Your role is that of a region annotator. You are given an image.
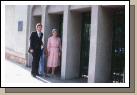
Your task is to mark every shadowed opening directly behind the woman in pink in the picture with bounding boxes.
[45,13,63,77]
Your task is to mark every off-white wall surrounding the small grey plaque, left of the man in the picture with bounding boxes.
[5,5,27,58]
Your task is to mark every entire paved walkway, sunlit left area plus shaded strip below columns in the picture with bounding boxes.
[5,60,87,83]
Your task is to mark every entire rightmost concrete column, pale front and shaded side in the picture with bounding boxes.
[88,6,112,83]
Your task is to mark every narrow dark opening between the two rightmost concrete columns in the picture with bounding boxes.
[80,12,91,77]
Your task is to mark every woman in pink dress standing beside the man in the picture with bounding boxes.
[47,29,61,75]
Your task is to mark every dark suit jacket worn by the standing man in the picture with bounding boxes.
[30,32,43,51]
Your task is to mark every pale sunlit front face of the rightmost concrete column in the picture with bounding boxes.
[88,6,98,82]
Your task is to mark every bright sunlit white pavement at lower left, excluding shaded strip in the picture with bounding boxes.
[5,60,46,83]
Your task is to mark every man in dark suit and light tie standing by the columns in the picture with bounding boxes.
[30,23,43,77]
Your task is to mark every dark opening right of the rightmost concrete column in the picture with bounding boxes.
[111,8,125,82]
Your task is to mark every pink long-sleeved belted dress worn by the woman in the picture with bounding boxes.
[47,36,61,67]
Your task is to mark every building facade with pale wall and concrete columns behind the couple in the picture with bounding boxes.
[5,5,125,83]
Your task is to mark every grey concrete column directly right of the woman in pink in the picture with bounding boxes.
[61,6,81,79]
